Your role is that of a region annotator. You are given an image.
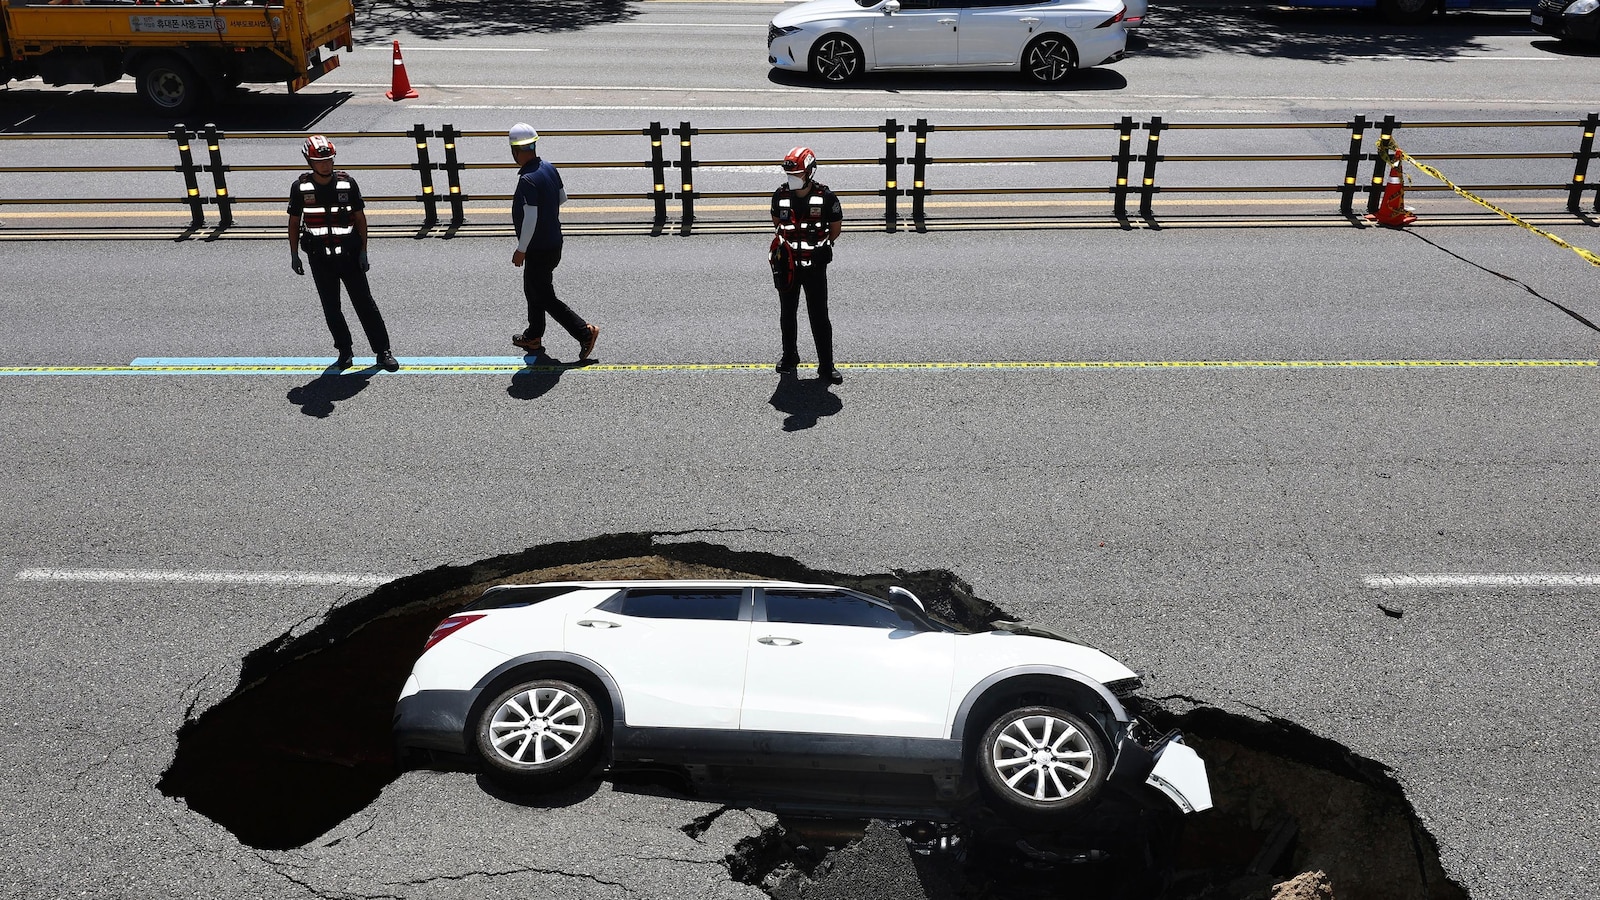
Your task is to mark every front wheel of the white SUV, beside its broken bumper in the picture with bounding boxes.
[973,706,1110,818]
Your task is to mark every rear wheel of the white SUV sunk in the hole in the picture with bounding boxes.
[472,679,605,788]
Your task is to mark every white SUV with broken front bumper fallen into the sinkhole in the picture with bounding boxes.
[394,581,1211,823]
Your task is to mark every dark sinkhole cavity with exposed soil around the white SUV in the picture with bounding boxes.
[160,535,1466,900]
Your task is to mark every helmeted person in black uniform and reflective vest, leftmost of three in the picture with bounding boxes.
[290,135,400,372]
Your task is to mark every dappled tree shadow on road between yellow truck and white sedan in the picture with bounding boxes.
[357,0,638,40]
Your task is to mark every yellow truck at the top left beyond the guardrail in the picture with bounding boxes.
[0,0,355,115]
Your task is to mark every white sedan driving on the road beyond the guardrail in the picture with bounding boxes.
[766,0,1144,83]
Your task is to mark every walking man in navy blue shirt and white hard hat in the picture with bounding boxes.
[510,122,600,359]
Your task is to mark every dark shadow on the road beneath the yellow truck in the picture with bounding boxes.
[0,85,355,135]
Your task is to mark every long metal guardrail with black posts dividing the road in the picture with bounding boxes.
[0,112,1600,237]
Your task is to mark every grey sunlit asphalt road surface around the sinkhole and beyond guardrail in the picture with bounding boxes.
[0,3,1600,898]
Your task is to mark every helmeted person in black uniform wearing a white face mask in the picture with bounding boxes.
[771,147,845,384]
